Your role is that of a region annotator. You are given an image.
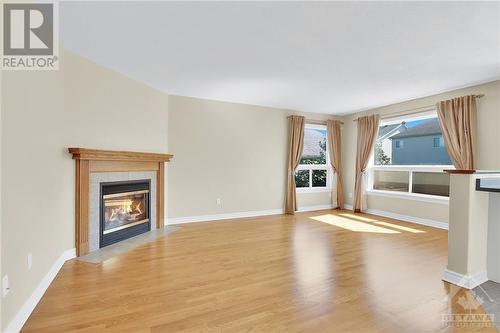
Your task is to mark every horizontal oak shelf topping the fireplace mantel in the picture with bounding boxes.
[68,148,173,162]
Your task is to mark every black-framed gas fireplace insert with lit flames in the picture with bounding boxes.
[99,179,151,247]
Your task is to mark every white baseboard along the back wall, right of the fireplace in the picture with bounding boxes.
[165,205,332,225]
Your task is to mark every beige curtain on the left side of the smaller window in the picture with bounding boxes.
[285,116,305,214]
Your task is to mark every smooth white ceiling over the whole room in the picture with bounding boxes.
[59,2,500,114]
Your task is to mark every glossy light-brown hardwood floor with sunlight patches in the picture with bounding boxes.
[23,211,496,333]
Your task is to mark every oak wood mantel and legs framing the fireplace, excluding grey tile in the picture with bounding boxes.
[68,148,173,256]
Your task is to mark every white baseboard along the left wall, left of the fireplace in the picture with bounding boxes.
[4,249,76,333]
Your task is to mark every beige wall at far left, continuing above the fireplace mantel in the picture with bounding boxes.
[1,51,168,328]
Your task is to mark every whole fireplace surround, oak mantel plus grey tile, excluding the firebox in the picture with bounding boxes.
[68,148,173,256]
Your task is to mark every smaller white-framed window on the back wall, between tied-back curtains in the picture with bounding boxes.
[295,124,331,192]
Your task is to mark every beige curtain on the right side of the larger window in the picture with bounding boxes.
[437,96,477,170]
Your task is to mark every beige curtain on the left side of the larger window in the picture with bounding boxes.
[354,115,380,212]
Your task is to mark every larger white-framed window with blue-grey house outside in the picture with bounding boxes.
[368,111,453,197]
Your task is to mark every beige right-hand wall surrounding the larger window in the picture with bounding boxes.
[342,81,500,222]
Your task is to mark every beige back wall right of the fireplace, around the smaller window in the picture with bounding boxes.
[167,96,336,218]
